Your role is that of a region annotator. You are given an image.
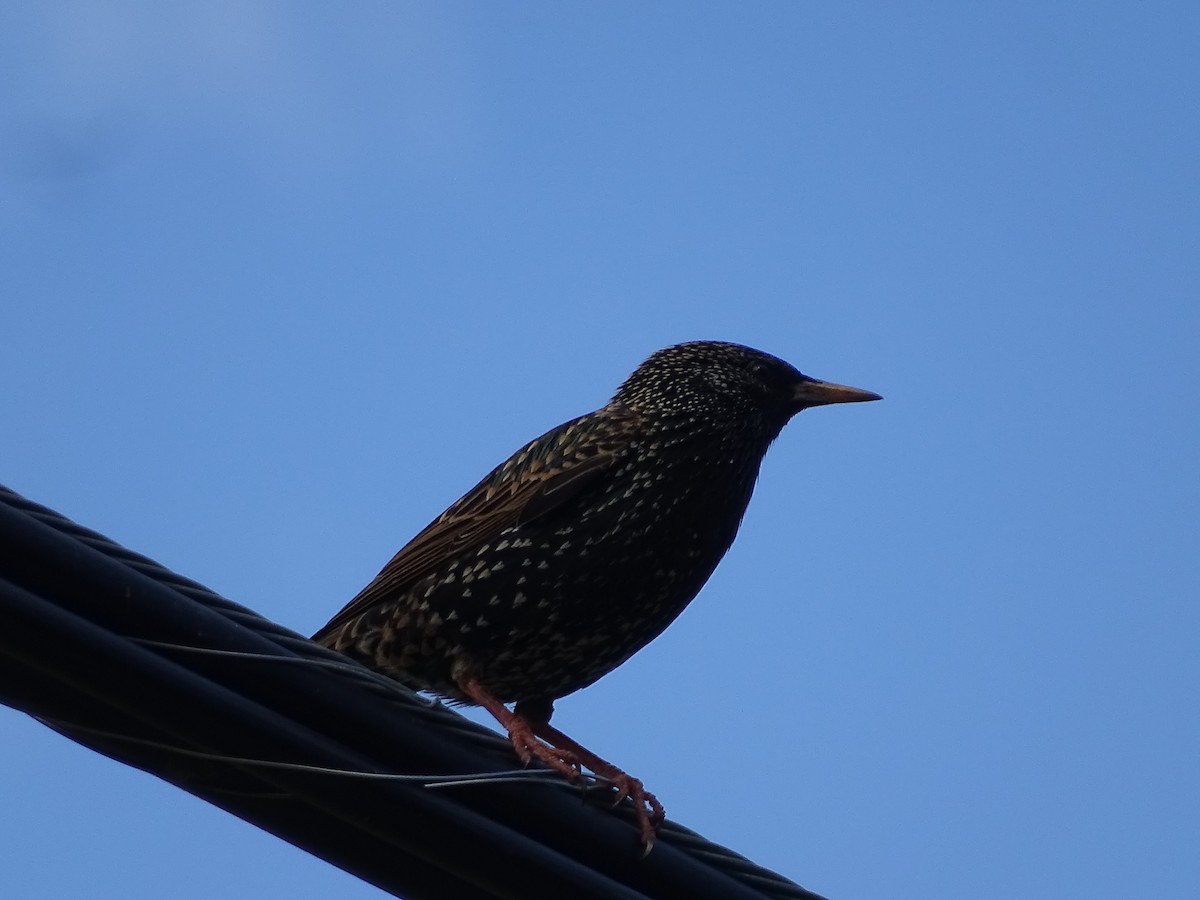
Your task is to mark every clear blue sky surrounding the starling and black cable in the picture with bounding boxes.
[0,0,1200,900]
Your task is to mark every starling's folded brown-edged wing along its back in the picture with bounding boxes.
[313,406,638,642]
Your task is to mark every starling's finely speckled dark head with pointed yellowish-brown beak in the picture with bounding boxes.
[613,341,880,437]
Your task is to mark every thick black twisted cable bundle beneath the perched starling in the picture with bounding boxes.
[0,487,820,900]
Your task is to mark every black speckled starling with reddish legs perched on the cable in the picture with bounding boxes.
[313,341,880,851]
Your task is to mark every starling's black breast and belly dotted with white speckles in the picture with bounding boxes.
[373,429,761,701]
